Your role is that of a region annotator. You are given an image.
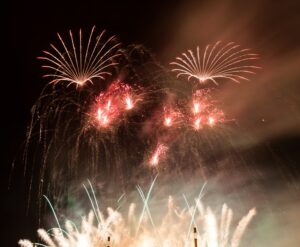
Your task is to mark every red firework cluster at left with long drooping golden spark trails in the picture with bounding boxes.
[23,43,171,216]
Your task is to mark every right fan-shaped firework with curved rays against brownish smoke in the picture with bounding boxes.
[170,41,259,84]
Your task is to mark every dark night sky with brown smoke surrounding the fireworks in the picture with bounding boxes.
[0,0,300,247]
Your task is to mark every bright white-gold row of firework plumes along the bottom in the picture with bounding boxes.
[19,182,256,247]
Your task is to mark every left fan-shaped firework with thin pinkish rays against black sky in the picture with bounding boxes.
[39,26,120,86]
